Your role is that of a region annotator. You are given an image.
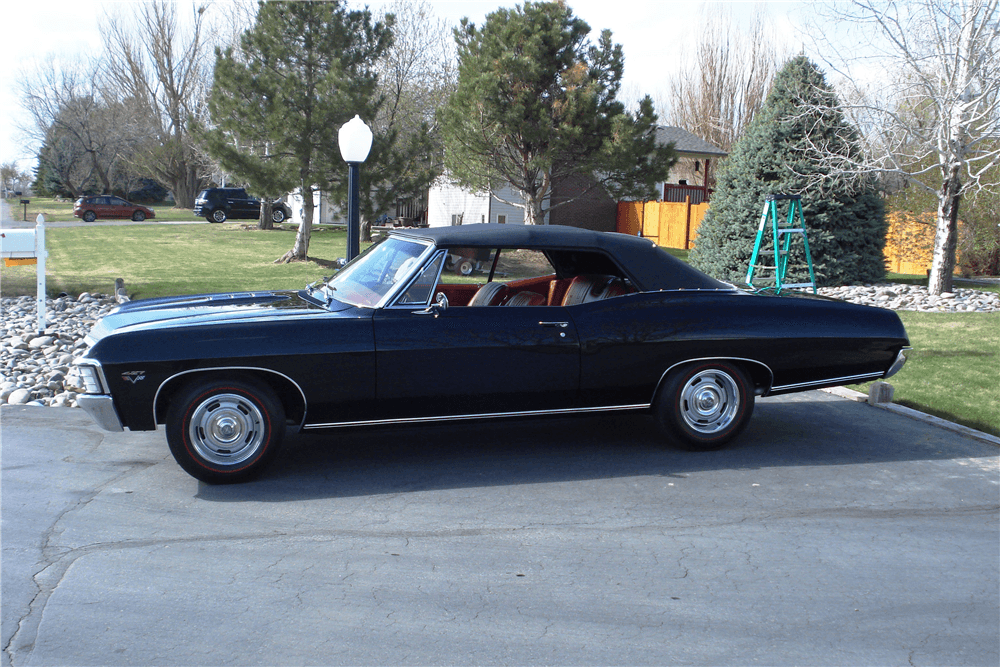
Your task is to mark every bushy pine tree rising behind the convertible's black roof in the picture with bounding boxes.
[439,2,676,224]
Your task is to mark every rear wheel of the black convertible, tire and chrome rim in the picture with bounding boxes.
[653,361,754,451]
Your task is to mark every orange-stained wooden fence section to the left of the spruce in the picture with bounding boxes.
[615,197,708,250]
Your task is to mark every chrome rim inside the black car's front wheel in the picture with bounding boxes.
[188,394,266,466]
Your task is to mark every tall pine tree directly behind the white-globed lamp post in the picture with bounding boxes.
[201,0,439,261]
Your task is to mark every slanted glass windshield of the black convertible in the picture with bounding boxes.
[326,237,429,308]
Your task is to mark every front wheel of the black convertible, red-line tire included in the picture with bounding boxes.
[166,380,285,484]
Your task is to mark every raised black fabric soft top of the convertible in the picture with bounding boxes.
[391,223,730,291]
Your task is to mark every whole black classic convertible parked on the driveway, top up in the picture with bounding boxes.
[74,224,908,483]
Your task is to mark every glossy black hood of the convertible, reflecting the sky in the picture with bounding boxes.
[87,291,350,345]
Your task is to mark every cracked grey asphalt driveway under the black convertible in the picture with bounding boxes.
[0,392,1000,667]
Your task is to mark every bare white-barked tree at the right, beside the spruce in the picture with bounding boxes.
[808,0,1000,294]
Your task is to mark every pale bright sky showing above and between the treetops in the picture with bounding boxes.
[0,0,810,175]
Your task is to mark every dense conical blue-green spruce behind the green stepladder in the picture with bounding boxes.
[691,56,886,286]
